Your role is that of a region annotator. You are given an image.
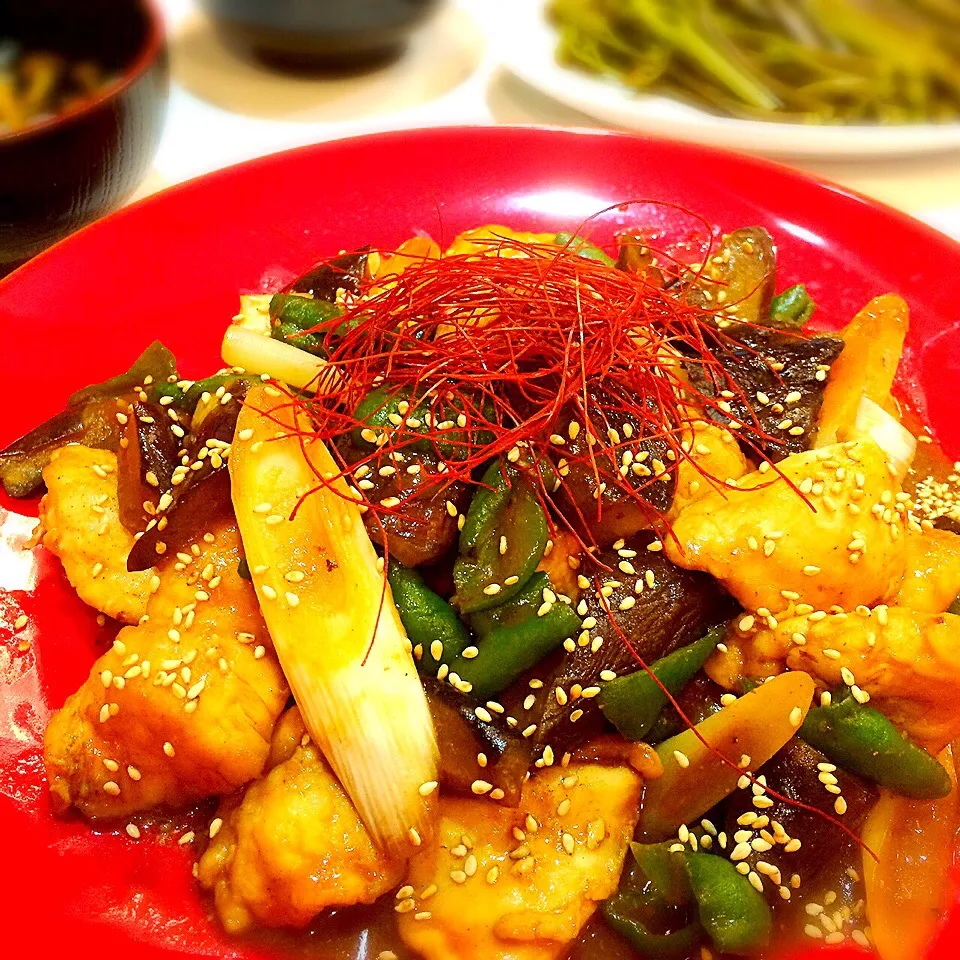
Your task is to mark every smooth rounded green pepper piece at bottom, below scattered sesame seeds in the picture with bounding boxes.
[685,853,773,954]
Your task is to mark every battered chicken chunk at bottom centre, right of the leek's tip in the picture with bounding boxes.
[399,764,641,960]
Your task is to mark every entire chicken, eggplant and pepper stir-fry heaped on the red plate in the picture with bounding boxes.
[0,226,960,960]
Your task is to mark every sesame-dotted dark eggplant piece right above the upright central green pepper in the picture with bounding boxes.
[555,389,676,547]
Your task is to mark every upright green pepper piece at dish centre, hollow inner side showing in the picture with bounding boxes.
[453,460,548,613]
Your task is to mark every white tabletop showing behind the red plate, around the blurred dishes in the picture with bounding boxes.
[148,0,960,239]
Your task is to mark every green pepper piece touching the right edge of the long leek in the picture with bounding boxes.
[387,561,470,676]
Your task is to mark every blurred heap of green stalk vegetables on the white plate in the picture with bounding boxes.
[548,0,960,124]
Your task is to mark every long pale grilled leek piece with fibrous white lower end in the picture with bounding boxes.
[230,385,437,851]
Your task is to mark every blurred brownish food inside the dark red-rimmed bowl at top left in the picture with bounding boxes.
[0,36,115,135]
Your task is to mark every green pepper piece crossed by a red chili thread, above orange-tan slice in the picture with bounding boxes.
[599,625,726,741]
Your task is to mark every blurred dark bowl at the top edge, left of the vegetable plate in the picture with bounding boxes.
[201,0,439,68]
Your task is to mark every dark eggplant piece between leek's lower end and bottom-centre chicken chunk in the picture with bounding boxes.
[424,678,533,807]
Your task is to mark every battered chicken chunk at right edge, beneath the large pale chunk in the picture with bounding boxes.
[724,607,960,753]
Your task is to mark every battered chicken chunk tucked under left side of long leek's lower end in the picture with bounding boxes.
[199,707,405,933]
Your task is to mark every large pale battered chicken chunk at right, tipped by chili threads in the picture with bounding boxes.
[664,440,906,612]
